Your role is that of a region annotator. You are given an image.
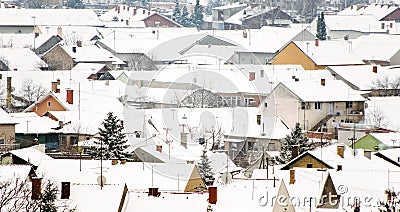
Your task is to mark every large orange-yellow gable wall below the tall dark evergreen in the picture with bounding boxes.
[271,42,326,70]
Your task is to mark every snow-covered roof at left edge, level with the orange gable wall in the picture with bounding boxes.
[0,48,47,71]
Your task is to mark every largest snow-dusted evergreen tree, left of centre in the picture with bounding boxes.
[92,112,131,159]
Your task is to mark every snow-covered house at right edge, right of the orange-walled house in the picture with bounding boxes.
[352,34,400,66]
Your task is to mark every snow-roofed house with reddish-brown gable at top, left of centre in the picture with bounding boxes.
[99,5,181,27]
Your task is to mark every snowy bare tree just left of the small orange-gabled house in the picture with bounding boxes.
[20,78,47,106]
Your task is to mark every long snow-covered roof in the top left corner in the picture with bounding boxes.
[0,8,101,27]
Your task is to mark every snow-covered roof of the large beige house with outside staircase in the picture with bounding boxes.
[281,80,366,102]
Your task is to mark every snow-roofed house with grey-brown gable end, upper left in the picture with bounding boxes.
[42,43,124,70]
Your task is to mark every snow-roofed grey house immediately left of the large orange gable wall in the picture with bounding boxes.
[233,26,315,65]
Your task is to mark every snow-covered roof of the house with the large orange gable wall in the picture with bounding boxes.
[293,40,365,65]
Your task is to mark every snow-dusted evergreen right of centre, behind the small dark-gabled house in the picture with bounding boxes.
[276,123,312,163]
